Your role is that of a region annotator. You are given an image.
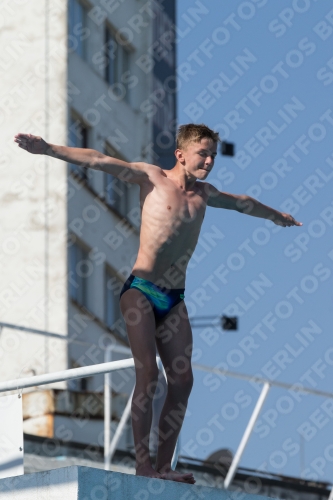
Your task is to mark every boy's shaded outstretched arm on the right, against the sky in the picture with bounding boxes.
[206,182,303,227]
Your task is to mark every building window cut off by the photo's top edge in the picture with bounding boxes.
[68,0,89,59]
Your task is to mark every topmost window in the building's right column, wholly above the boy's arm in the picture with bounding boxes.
[104,26,131,102]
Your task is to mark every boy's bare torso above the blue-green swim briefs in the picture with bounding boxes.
[132,167,208,288]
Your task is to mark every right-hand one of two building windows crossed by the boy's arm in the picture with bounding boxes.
[104,143,130,217]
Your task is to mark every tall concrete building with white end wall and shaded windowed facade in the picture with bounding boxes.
[0,0,175,448]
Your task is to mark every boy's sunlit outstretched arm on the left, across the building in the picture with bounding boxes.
[14,134,150,184]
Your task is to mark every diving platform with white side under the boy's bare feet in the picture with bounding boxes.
[0,465,276,500]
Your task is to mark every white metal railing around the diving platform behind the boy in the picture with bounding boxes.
[0,322,333,492]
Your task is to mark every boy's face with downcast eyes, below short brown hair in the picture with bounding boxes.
[177,138,217,180]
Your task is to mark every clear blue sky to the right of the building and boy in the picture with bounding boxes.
[177,0,333,481]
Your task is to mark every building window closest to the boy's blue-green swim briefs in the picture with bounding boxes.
[105,267,123,330]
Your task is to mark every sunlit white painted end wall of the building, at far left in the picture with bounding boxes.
[0,0,67,379]
